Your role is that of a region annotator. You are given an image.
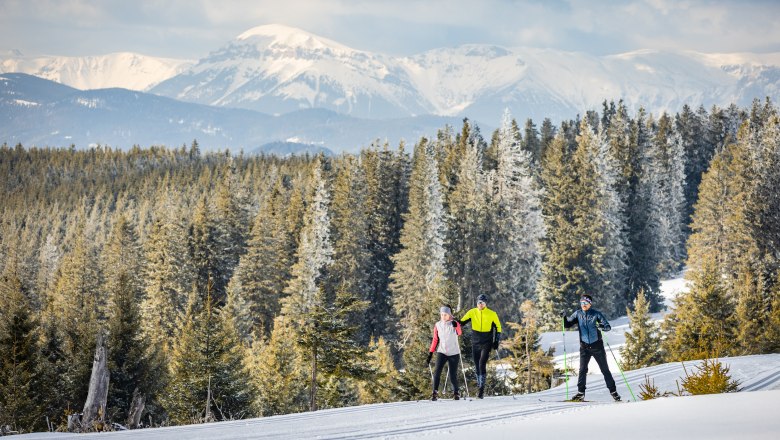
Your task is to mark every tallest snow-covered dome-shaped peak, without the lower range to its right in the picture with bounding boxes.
[153,25,429,118]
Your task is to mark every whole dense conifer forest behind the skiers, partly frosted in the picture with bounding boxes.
[0,100,780,432]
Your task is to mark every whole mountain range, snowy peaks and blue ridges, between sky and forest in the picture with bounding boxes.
[0,25,780,152]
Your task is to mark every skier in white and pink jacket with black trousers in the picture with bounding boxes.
[426,305,462,400]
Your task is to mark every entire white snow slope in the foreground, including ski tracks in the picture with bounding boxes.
[16,354,780,440]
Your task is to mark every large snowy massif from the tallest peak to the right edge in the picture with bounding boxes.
[151,25,780,124]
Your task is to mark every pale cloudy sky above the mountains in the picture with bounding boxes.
[0,0,780,59]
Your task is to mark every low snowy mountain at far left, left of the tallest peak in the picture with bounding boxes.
[0,51,192,90]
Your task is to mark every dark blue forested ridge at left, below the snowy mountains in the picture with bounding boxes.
[0,73,459,151]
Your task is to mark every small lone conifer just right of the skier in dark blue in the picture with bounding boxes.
[620,290,662,370]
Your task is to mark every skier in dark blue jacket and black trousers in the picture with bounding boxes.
[562,295,620,401]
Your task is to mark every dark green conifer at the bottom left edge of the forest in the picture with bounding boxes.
[0,262,46,433]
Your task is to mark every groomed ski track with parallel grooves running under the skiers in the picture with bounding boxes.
[15,354,780,440]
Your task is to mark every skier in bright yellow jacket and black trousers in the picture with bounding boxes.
[460,293,501,399]
